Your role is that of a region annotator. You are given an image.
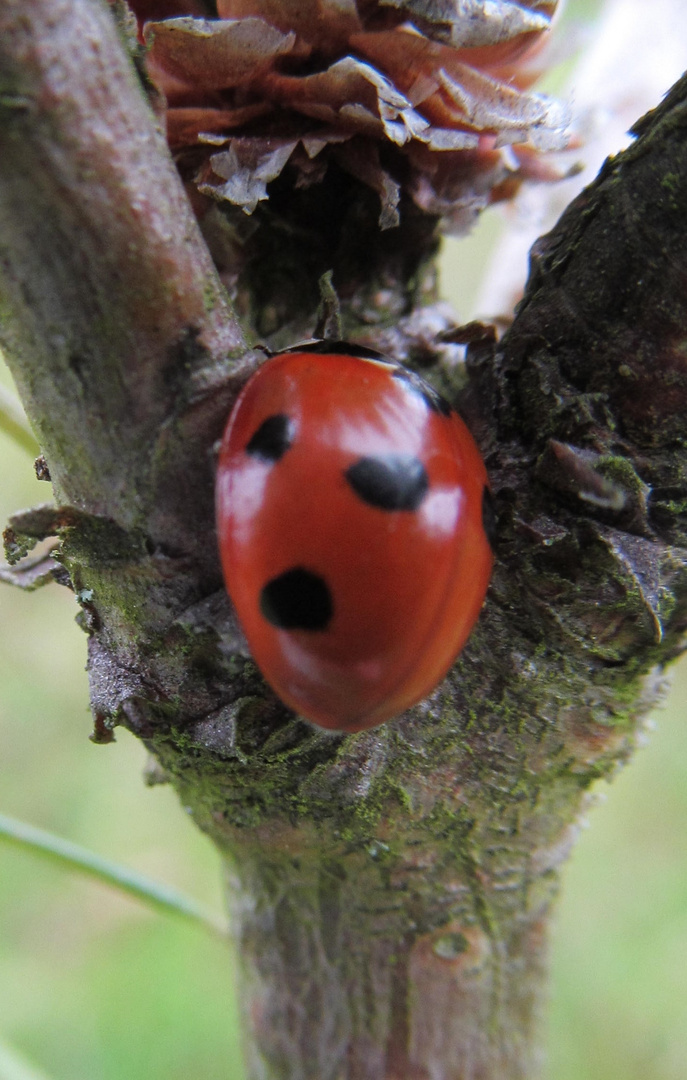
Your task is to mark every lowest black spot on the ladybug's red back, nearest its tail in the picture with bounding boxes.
[260,566,334,630]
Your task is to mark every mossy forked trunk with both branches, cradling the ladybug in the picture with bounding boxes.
[0,6,687,1080]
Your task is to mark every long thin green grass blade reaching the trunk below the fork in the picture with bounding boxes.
[0,814,227,937]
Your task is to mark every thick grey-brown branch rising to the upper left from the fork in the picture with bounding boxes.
[0,0,243,565]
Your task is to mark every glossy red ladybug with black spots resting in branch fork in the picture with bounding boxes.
[216,341,493,731]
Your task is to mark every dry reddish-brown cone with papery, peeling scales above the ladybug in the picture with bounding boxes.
[119,0,567,231]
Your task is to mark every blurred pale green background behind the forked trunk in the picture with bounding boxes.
[0,0,687,1080]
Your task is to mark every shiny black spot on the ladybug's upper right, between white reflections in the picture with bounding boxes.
[345,454,429,510]
